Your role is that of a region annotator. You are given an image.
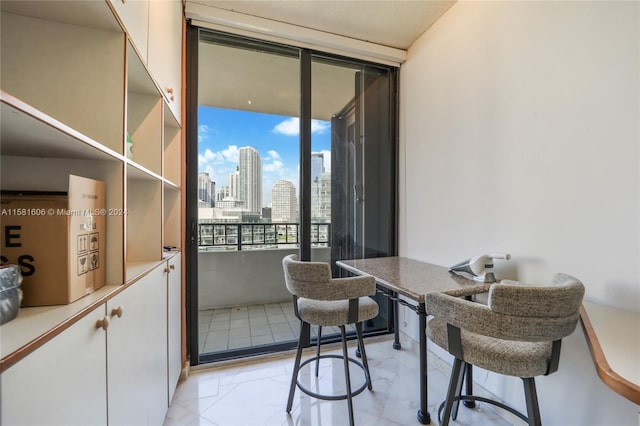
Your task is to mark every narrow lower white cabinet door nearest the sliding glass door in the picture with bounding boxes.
[167,253,182,403]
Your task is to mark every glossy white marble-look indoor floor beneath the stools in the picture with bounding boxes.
[164,334,520,426]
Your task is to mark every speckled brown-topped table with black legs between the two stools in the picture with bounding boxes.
[336,257,490,424]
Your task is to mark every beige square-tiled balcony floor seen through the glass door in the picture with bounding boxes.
[198,301,352,353]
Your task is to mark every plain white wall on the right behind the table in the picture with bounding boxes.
[400,1,640,425]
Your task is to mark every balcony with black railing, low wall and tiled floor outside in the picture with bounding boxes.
[198,223,337,353]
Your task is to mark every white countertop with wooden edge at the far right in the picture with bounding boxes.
[580,302,640,405]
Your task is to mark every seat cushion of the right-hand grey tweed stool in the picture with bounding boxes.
[427,318,551,377]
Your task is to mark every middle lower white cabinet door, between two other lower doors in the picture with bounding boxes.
[107,264,168,425]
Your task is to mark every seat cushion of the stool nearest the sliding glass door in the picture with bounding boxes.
[298,297,378,326]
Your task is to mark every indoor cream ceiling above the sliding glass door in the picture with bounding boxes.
[186,0,455,50]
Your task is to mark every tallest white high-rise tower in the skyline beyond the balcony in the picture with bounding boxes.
[238,146,262,216]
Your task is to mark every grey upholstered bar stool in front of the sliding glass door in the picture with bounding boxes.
[282,255,378,425]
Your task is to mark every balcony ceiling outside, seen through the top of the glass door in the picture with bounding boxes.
[198,42,358,121]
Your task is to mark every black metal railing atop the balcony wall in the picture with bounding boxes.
[198,223,331,250]
